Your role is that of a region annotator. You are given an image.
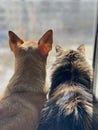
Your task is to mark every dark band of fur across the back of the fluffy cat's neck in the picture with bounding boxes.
[50,61,93,95]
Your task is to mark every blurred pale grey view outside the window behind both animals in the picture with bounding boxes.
[0,0,98,97]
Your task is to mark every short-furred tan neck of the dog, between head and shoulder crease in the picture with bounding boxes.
[4,55,46,96]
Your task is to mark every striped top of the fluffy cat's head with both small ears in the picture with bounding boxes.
[55,45,86,63]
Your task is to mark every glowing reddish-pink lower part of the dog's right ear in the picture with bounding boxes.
[40,43,52,56]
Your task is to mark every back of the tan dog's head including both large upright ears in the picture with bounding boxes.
[9,30,53,71]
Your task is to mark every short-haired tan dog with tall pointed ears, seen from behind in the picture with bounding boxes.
[0,30,53,130]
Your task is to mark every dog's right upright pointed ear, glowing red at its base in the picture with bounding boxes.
[38,30,53,56]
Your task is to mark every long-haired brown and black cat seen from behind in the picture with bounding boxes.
[37,45,95,130]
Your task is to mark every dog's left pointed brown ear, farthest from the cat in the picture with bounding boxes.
[8,31,23,52]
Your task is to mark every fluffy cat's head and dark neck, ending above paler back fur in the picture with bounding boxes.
[52,45,93,92]
